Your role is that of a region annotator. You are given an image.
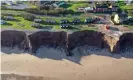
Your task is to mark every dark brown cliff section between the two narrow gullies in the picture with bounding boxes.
[29,31,67,52]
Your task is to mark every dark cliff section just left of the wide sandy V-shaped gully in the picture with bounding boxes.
[68,30,107,50]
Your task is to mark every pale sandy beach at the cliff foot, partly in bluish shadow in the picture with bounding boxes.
[1,48,133,80]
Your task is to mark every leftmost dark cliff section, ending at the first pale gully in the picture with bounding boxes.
[1,30,29,50]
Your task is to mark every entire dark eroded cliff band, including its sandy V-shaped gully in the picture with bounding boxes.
[1,30,133,53]
